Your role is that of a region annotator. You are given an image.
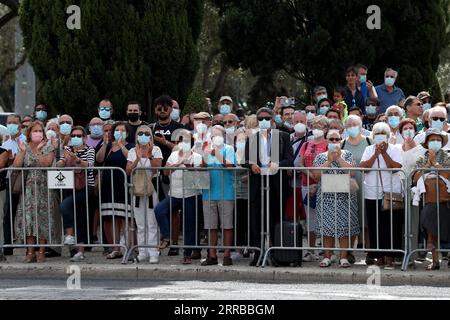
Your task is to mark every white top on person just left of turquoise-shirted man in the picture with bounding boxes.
[167,148,202,199]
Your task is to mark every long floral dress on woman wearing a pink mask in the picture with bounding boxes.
[15,145,55,243]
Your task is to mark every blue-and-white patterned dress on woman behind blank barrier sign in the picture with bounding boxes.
[314,150,360,238]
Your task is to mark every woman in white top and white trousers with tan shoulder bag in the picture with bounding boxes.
[126,125,163,263]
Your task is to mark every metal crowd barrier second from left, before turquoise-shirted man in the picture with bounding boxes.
[124,167,262,261]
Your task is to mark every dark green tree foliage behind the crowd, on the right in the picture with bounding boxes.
[215,0,449,101]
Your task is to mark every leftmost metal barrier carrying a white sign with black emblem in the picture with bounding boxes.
[0,167,130,258]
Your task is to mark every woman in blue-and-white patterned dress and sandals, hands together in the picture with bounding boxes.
[313,130,359,268]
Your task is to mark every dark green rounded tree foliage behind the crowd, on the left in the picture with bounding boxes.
[20,0,203,120]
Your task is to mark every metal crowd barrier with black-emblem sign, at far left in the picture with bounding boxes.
[0,167,130,262]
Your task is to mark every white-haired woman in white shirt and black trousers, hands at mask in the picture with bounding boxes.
[360,122,404,269]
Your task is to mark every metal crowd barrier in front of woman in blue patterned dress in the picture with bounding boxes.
[262,167,409,266]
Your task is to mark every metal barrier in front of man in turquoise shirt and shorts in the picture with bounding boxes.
[124,167,262,261]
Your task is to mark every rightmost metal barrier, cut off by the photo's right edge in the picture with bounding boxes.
[403,168,450,270]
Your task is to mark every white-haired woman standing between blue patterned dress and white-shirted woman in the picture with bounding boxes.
[341,115,373,255]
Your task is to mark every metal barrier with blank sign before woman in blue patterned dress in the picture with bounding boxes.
[262,168,409,266]
